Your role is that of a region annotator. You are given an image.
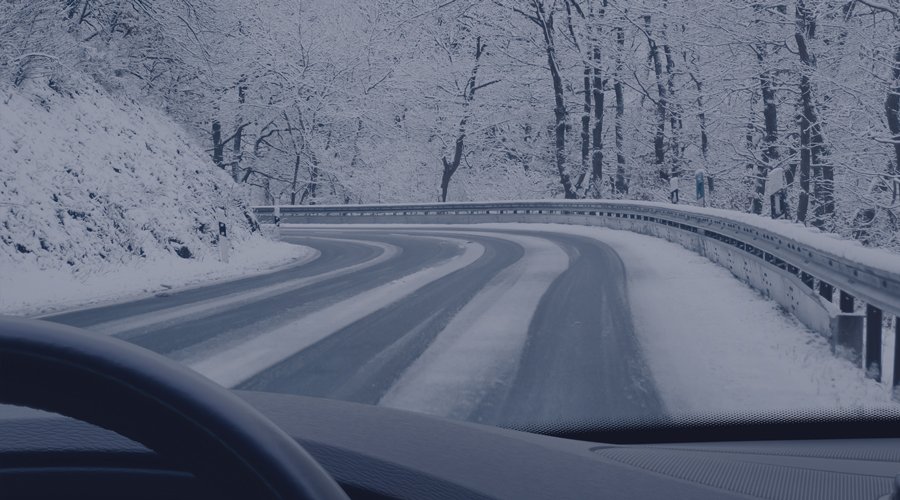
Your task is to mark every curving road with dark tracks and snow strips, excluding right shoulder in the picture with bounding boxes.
[47,226,660,424]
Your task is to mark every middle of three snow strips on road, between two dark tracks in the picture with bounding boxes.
[185,238,484,387]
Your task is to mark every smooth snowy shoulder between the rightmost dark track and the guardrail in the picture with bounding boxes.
[300,224,896,413]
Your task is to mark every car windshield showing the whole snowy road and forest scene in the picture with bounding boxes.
[0,0,900,426]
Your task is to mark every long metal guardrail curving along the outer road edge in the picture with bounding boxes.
[253,201,900,385]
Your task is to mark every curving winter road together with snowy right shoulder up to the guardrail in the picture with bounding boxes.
[47,224,891,424]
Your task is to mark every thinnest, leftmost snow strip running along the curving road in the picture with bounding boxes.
[90,238,402,339]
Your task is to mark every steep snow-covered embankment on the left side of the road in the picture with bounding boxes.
[0,82,310,312]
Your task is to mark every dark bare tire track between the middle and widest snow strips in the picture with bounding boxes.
[236,231,525,405]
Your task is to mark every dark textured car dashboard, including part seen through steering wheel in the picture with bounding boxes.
[0,391,900,500]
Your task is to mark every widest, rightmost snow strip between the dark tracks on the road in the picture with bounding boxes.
[378,231,569,419]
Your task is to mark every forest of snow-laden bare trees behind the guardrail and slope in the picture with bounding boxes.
[0,0,900,248]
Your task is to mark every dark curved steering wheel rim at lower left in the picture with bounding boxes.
[0,317,347,500]
